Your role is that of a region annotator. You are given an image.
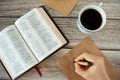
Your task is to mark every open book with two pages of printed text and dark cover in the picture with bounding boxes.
[0,7,67,79]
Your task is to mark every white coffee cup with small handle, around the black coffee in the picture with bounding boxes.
[77,3,106,34]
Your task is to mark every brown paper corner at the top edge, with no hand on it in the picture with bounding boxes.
[41,0,78,16]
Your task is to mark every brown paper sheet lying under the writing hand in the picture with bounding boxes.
[57,38,120,80]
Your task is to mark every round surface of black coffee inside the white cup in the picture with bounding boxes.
[81,9,102,30]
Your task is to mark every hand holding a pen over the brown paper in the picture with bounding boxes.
[74,53,110,80]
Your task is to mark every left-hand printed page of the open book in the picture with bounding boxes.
[0,25,38,79]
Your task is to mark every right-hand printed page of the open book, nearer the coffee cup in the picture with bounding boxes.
[15,9,65,61]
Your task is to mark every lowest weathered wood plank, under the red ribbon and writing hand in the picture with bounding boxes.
[0,49,120,80]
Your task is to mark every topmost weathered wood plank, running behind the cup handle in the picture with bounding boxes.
[0,0,120,19]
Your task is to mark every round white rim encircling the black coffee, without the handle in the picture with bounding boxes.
[78,5,106,32]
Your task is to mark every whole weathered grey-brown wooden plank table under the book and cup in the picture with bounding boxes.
[0,0,120,80]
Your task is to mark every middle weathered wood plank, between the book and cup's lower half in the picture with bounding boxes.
[0,18,120,50]
